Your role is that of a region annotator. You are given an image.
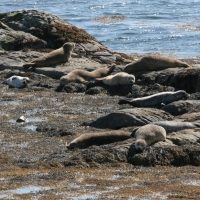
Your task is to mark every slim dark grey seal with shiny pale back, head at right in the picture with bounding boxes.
[119,90,188,107]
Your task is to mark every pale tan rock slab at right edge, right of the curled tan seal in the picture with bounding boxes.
[167,128,200,145]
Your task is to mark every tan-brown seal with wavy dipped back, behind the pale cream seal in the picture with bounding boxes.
[60,66,115,85]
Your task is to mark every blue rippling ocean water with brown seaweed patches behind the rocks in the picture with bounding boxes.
[0,0,200,58]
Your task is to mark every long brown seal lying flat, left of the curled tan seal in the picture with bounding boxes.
[66,130,131,149]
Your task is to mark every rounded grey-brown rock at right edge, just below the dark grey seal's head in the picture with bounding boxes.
[163,100,200,116]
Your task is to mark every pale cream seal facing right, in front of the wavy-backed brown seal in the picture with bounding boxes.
[97,72,135,86]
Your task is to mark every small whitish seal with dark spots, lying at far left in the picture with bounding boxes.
[3,75,30,88]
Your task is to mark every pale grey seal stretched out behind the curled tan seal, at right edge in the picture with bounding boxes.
[151,121,200,133]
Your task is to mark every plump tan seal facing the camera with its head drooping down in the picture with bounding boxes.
[135,124,166,151]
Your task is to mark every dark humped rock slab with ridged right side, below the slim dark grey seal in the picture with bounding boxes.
[89,108,173,129]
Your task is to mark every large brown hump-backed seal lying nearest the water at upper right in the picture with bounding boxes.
[124,55,190,74]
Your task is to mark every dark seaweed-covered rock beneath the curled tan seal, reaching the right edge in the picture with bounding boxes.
[128,144,200,166]
